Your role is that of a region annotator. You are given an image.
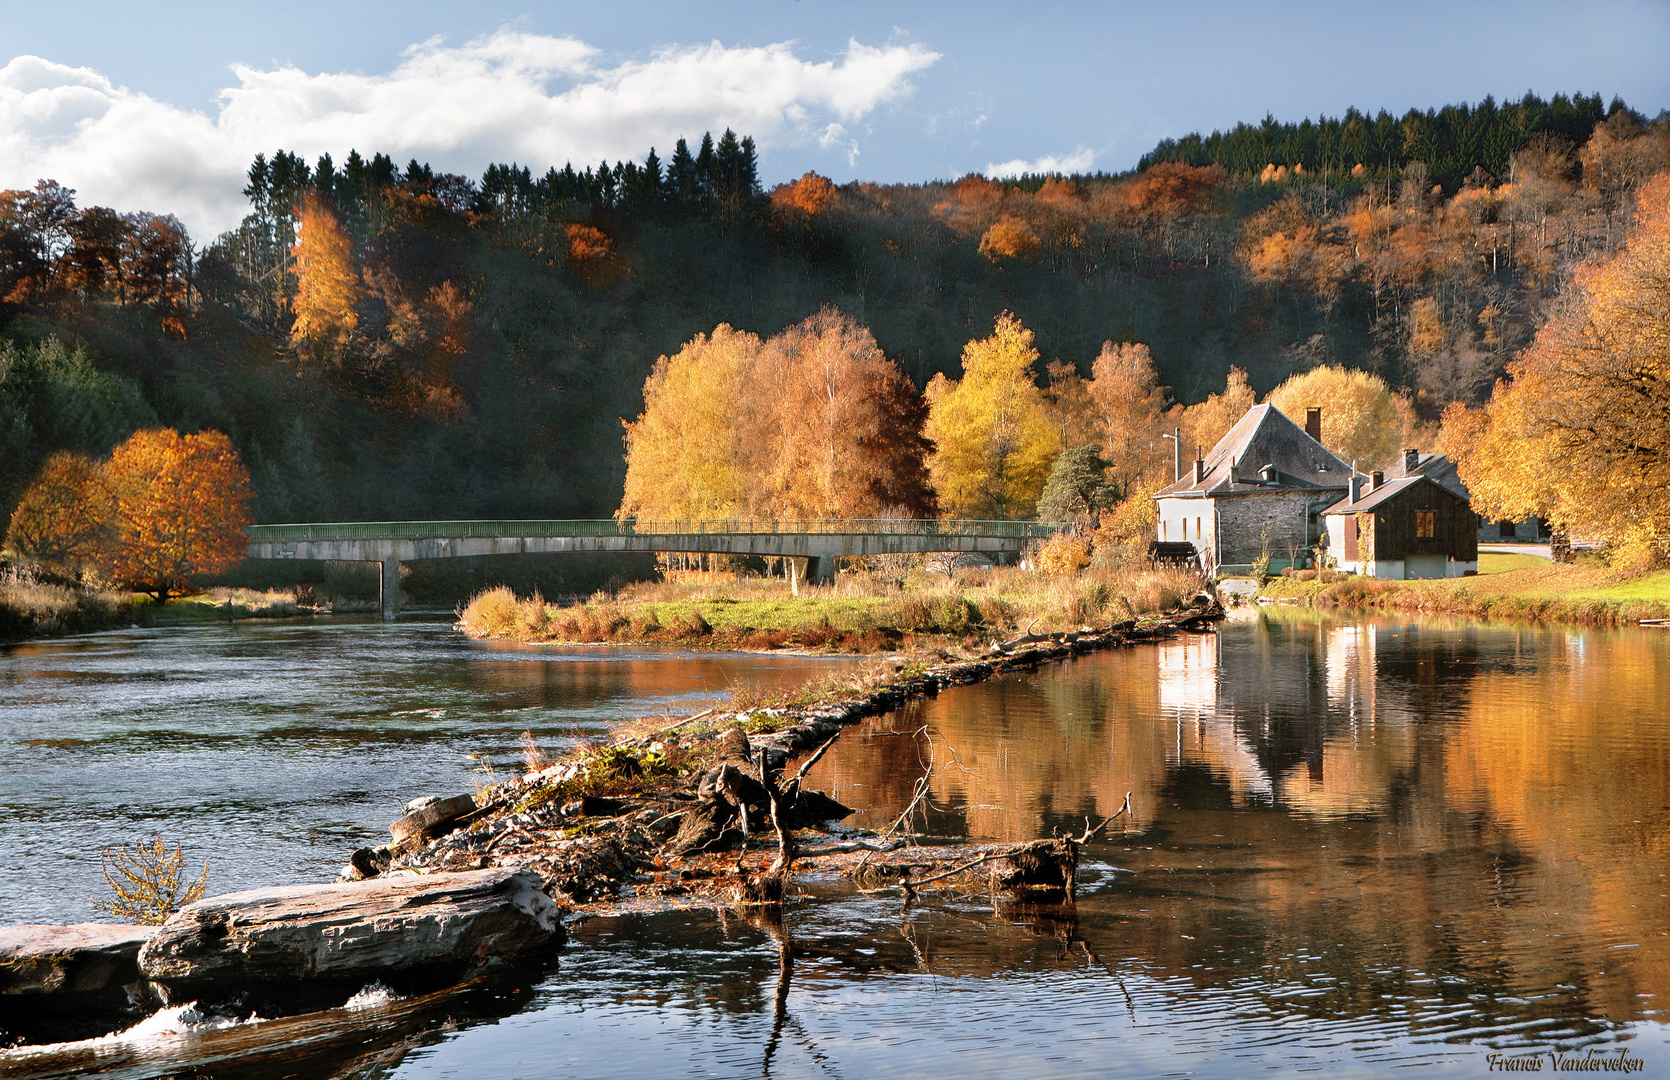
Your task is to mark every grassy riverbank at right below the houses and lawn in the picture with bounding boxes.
[1259,558,1670,626]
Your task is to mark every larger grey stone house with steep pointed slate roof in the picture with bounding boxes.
[1154,404,1351,574]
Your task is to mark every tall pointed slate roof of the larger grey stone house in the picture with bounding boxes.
[1154,404,1351,499]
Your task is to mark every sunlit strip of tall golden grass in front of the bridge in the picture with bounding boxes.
[459,568,1199,653]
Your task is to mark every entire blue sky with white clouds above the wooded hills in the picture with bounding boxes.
[0,0,1670,239]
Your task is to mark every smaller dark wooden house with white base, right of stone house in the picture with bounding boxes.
[1323,451,1478,581]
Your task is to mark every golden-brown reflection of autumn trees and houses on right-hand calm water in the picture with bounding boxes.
[798,618,1670,1032]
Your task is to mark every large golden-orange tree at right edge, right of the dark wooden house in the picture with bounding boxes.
[1445,175,1670,543]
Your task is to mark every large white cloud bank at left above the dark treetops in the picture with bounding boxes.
[0,30,939,239]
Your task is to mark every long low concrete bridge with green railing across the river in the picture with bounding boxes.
[249,517,1069,619]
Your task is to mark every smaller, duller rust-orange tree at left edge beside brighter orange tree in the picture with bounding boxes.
[5,451,114,578]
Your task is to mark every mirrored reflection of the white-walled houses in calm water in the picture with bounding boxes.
[1161,621,1430,816]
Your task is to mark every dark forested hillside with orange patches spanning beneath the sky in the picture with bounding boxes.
[0,97,1670,521]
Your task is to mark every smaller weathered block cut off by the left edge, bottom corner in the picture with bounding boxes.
[0,923,157,1045]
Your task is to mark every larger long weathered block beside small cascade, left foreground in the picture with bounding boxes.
[139,868,563,1015]
